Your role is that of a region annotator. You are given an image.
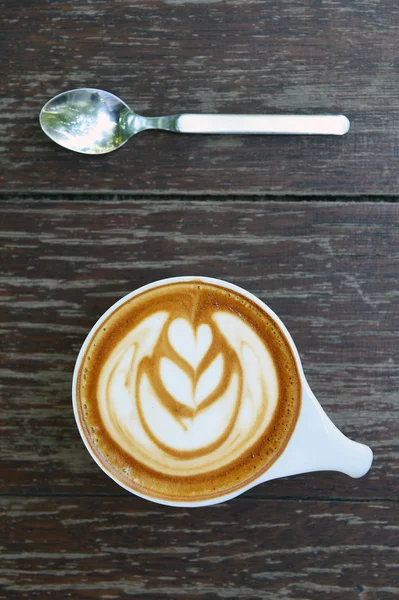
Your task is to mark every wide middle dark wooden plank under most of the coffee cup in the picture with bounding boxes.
[0,197,399,498]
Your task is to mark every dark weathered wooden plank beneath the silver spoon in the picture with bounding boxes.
[0,0,399,195]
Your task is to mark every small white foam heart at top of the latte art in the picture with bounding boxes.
[168,318,213,369]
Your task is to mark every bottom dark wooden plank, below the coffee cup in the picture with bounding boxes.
[0,498,399,600]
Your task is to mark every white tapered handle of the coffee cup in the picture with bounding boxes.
[261,380,373,482]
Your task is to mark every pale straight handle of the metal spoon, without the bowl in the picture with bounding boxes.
[176,114,350,135]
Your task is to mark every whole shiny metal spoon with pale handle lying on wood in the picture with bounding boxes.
[40,88,349,154]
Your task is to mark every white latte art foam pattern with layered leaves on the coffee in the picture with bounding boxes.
[98,311,278,475]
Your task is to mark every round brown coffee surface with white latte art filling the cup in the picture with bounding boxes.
[77,280,301,502]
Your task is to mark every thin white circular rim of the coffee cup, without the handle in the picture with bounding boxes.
[72,275,307,508]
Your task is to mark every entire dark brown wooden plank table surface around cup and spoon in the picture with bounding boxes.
[0,0,399,600]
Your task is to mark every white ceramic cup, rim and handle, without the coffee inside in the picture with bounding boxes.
[72,276,373,507]
